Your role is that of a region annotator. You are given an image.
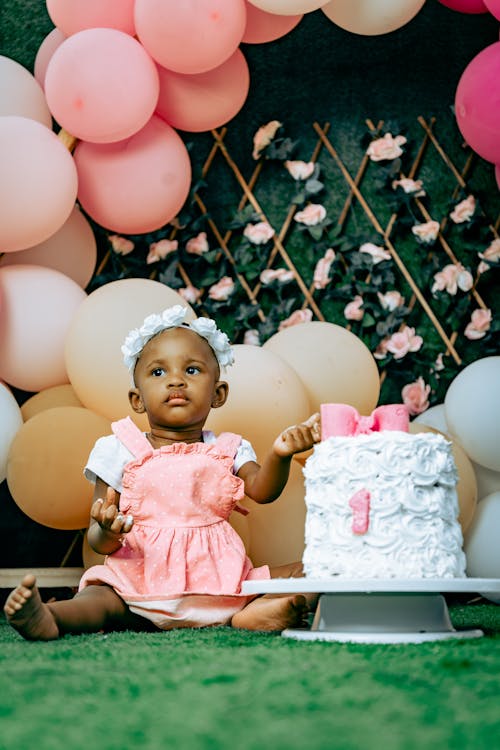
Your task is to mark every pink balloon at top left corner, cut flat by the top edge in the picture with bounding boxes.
[46,0,135,36]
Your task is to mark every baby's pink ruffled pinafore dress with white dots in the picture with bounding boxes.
[80,418,270,629]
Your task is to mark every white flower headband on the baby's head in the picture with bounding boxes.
[122,305,234,375]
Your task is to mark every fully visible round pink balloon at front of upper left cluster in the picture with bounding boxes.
[45,29,160,143]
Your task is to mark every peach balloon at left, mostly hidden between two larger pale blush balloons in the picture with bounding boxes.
[0,205,97,289]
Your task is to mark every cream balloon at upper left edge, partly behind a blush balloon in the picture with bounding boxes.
[0,55,52,129]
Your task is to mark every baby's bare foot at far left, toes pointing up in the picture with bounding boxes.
[4,574,59,641]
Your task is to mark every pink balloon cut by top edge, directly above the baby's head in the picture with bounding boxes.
[135,0,246,73]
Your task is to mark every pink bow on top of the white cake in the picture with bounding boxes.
[320,404,409,440]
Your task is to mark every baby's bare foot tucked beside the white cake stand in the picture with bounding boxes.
[231,594,309,632]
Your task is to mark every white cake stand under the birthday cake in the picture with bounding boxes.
[242,578,500,643]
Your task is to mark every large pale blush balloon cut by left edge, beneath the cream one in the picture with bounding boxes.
[0,116,78,253]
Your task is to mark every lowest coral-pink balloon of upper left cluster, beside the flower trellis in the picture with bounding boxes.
[74,117,191,234]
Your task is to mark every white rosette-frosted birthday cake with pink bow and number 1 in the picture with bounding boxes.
[303,404,465,579]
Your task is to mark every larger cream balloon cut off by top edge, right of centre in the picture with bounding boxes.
[321,0,425,36]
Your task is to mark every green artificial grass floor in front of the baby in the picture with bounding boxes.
[0,604,500,750]
